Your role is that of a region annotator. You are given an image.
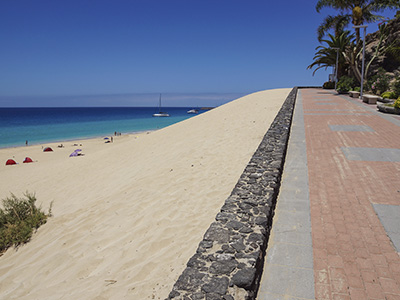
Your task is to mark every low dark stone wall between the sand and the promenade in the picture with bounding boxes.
[168,87,298,300]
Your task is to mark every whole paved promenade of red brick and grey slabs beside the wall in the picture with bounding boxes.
[258,89,400,300]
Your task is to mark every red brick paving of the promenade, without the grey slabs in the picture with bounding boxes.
[301,89,400,300]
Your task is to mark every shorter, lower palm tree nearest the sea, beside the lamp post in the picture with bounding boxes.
[307,30,354,78]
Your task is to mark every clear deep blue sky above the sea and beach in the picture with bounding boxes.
[0,0,394,107]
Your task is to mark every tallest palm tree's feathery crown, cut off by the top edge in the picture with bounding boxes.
[315,0,400,43]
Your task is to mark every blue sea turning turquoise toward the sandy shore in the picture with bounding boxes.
[0,107,204,148]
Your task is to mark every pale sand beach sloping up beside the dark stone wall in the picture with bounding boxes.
[0,89,291,300]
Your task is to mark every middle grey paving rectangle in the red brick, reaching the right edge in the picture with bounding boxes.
[341,147,400,162]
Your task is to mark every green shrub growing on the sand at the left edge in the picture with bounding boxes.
[0,192,51,253]
